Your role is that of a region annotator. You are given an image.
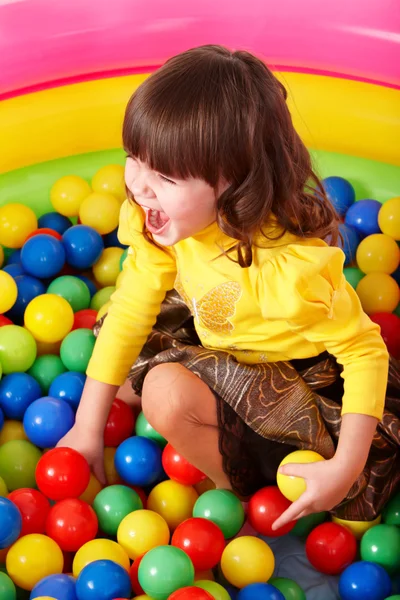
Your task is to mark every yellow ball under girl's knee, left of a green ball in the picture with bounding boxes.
[147,480,199,531]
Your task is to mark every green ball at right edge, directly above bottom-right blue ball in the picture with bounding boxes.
[360,524,400,574]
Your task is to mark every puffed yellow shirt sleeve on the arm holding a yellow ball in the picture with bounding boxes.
[258,245,389,420]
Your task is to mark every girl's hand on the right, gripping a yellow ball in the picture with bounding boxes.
[272,457,358,529]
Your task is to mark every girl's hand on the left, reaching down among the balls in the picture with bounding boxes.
[57,424,106,485]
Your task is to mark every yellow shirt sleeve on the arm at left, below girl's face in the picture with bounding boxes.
[87,200,176,385]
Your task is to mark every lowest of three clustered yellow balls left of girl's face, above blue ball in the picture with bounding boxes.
[79,192,121,235]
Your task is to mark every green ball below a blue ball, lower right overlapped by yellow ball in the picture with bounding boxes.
[93,485,143,535]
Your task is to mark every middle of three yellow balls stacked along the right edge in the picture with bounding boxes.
[357,233,400,275]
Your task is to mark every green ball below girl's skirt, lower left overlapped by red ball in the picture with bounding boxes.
[193,490,244,540]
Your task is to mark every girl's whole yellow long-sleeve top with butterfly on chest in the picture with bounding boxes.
[87,201,388,419]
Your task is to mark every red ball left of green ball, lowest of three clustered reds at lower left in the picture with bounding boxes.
[46,498,98,552]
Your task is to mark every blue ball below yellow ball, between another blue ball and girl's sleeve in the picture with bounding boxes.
[62,225,104,270]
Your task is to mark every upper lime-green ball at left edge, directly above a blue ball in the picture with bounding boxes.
[0,325,37,375]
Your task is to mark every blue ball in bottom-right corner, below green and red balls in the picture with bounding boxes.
[339,561,392,600]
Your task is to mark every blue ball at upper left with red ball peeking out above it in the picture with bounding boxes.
[21,233,65,279]
